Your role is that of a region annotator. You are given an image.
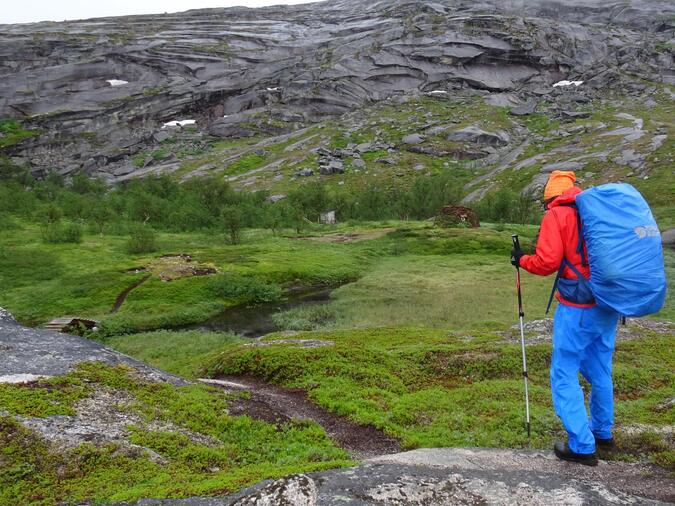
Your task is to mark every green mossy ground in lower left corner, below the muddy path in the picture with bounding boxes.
[0,363,349,505]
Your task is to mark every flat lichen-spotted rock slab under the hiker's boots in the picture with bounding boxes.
[138,448,675,506]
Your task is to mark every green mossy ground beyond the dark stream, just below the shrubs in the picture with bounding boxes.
[0,224,378,333]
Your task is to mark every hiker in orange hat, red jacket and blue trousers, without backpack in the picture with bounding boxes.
[511,170,619,466]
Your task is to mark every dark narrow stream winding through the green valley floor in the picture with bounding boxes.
[189,286,336,338]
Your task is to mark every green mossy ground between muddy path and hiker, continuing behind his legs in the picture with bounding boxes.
[208,328,675,451]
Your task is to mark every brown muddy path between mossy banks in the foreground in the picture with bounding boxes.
[199,376,401,460]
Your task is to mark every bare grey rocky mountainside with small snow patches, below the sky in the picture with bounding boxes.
[0,0,675,193]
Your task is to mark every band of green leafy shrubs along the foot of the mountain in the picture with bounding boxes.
[0,170,539,243]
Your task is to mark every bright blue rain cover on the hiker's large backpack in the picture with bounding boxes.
[576,183,666,316]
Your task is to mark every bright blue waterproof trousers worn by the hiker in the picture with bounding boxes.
[551,304,619,453]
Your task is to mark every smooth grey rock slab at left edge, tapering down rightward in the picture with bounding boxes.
[0,308,187,385]
